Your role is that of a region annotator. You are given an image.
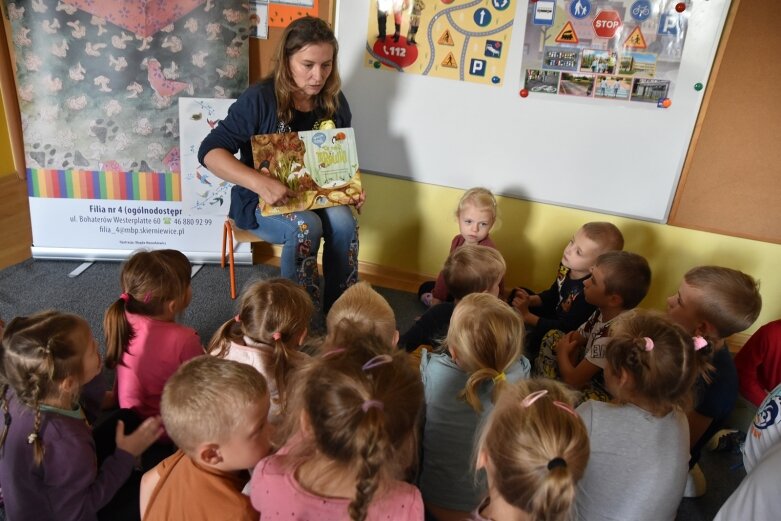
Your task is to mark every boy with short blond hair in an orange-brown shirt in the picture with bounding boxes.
[141,356,271,521]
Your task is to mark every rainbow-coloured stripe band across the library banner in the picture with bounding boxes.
[27,168,182,201]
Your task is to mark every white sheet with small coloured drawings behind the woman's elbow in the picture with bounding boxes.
[179,98,236,215]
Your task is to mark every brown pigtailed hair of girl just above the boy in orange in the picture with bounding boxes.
[207,278,314,409]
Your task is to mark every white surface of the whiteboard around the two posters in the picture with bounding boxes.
[336,0,729,222]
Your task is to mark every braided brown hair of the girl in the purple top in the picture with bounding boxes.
[0,311,89,465]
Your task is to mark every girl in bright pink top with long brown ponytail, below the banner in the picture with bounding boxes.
[103,250,204,418]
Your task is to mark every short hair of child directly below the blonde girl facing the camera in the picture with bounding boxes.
[442,244,507,300]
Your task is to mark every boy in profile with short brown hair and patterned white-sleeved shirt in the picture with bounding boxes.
[535,251,651,401]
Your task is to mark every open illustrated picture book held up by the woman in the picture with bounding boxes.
[252,128,361,216]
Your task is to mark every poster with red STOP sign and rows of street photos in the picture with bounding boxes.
[521,0,692,104]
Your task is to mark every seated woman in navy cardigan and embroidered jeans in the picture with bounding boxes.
[198,16,364,313]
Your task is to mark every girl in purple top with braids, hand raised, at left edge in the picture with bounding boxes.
[0,311,162,520]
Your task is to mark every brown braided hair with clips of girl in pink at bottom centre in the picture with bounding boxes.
[283,335,423,521]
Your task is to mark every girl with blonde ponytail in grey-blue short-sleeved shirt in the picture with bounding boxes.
[420,293,530,521]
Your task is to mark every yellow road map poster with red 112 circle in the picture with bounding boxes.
[365,0,519,85]
